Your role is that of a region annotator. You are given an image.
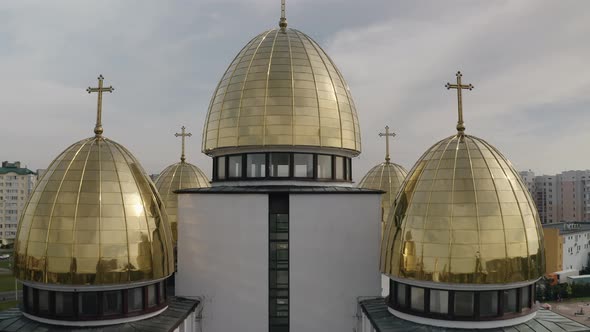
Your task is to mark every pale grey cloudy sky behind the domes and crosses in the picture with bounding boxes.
[0,0,590,181]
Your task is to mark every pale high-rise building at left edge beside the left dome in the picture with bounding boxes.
[0,161,37,245]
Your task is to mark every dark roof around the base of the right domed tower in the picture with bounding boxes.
[360,298,590,332]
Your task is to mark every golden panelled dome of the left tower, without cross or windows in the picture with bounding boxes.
[14,134,174,285]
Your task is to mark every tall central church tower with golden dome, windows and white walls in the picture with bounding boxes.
[176,3,381,332]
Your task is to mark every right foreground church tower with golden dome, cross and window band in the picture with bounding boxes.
[381,72,545,329]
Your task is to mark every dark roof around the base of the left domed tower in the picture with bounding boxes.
[0,297,199,332]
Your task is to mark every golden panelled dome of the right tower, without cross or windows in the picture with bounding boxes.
[381,132,545,284]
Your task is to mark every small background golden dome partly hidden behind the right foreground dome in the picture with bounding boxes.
[358,162,408,222]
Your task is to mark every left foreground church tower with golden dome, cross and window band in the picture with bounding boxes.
[14,76,174,327]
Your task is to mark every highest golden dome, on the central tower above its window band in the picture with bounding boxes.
[202,28,361,155]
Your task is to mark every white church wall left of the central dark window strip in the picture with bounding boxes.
[176,194,268,332]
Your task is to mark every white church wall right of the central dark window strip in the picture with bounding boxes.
[289,194,381,332]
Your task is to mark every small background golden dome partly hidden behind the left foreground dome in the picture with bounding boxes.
[156,162,211,243]
